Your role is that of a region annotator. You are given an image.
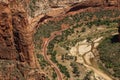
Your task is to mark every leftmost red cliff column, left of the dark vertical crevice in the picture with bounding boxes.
[0,3,18,59]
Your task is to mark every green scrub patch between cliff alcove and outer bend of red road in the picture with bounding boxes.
[34,21,61,48]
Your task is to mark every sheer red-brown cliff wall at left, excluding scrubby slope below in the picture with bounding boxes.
[0,3,35,67]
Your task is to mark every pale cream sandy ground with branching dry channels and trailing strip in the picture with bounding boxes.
[70,37,112,80]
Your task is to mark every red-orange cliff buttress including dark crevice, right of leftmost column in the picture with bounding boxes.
[12,12,35,67]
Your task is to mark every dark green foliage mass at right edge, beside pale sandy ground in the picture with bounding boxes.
[98,37,120,78]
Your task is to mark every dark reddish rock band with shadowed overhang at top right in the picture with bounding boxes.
[68,0,120,12]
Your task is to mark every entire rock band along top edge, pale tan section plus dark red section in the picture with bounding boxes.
[29,0,120,17]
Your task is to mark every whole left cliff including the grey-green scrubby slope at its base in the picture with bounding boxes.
[0,2,38,80]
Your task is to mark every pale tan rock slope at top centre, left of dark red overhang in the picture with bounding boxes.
[29,0,85,17]
